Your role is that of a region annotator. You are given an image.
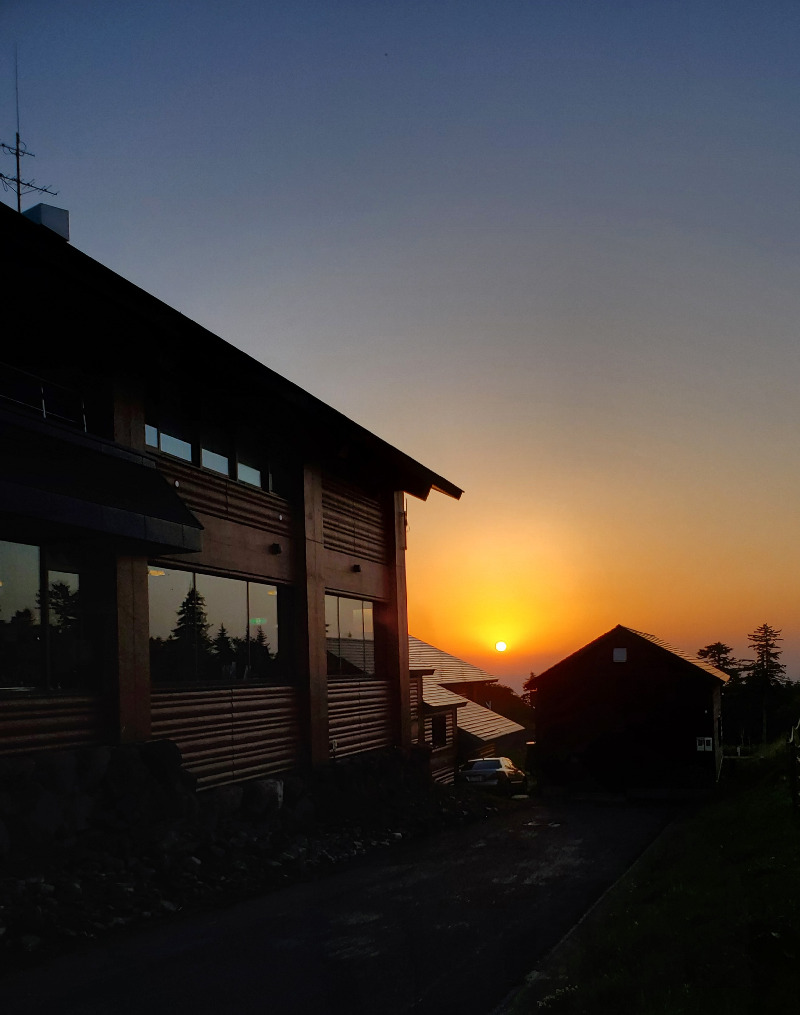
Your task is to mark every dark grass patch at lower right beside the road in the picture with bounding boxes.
[509,751,800,1015]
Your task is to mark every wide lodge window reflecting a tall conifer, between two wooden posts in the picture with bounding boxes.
[148,564,289,685]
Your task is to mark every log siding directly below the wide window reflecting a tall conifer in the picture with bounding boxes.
[152,685,301,788]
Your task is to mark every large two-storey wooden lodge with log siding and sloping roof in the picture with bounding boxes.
[0,206,461,787]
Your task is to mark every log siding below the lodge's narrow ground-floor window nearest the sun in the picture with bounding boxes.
[328,677,393,757]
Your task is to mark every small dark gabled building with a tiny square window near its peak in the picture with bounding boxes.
[526,624,728,791]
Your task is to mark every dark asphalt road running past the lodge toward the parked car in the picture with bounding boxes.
[0,801,672,1015]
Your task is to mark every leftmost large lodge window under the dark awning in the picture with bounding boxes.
[0,540,108,691]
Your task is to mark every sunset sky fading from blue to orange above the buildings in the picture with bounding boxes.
[0,0,800,686]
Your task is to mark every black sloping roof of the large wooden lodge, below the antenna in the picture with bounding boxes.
[0,204,462,500]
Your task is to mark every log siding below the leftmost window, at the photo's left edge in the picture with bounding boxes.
[0,696,109,754]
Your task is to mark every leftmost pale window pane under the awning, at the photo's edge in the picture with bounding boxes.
[0,541,44,687]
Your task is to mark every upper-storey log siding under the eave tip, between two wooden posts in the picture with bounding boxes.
[322,476,389,563]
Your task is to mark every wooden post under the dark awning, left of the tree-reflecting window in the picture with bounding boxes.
[117,557,150,743]
